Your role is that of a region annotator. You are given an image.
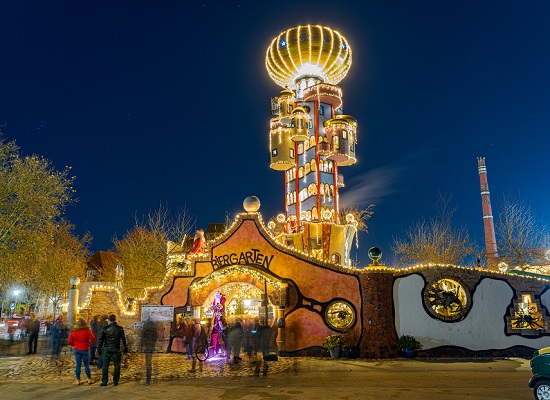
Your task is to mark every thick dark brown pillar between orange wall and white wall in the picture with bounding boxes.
[360,268,397,358]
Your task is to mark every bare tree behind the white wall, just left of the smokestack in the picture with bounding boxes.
[392,194,474,265]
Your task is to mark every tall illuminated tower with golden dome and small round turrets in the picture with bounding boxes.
[265,25,357,266]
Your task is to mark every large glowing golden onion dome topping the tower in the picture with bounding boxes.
[265,25,351,88]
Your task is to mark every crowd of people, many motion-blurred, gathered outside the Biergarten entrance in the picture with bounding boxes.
[3,304,276,386]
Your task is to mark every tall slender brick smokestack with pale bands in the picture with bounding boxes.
[477,157,498,271]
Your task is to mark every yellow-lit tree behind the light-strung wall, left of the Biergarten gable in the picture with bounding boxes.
[113,204,195,298]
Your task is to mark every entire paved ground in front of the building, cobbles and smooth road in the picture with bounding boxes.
[0,340,533,400]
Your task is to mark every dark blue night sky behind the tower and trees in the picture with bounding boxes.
[0,0,550,265]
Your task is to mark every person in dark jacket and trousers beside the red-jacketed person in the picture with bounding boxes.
[97,314,128,386]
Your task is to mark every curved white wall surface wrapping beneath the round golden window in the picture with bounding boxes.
[393,274,550,351]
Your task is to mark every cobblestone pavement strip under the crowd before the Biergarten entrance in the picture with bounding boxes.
[0,353,297,384]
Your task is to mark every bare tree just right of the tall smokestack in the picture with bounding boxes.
[495,196,550,268]
